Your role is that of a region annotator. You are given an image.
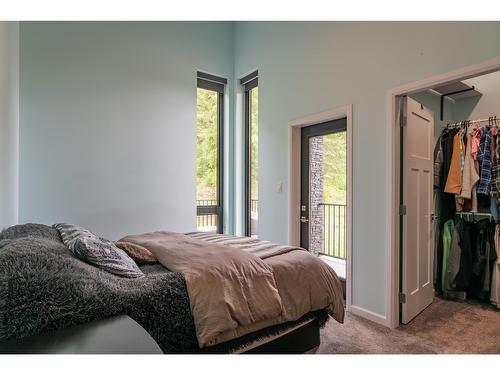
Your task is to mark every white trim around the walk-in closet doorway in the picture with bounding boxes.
[386,58,500,328]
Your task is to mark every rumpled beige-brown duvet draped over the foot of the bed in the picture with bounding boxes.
[120,232,344,347]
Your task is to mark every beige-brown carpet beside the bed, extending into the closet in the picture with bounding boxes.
[312,298,500,354]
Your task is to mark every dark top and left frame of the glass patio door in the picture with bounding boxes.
[300,117,347,249]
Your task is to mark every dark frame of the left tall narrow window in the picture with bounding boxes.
[196,72,227,233]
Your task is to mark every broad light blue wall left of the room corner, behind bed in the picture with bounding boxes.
[20,22,233,239]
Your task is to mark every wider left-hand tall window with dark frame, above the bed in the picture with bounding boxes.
[196,72,227,233]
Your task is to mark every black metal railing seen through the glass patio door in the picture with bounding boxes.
[319,203,347,260]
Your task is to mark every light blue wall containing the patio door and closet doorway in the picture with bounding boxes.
[234,22,500,315]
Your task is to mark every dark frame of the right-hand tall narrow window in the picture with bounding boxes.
[240,70,259,236]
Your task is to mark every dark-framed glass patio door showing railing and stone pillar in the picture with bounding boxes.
[300,118,347,260]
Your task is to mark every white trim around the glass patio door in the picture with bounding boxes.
[288,105,353,311]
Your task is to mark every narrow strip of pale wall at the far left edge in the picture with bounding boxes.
[0,22,19,230]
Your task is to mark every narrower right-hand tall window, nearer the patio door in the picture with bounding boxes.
[240,71,259,237]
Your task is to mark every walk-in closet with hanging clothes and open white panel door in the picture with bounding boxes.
[400,72,500,323]
